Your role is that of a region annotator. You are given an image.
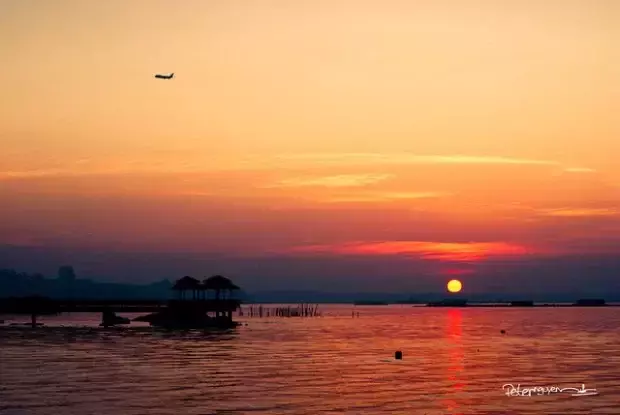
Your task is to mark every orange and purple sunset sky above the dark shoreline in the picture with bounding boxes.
[0,0,620,292]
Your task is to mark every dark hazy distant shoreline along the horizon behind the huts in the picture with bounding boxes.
[0,266,620,304]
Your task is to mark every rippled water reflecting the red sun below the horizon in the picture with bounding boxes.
[0,306,620,415]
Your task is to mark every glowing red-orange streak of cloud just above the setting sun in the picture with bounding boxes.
[289,241,528,262]
